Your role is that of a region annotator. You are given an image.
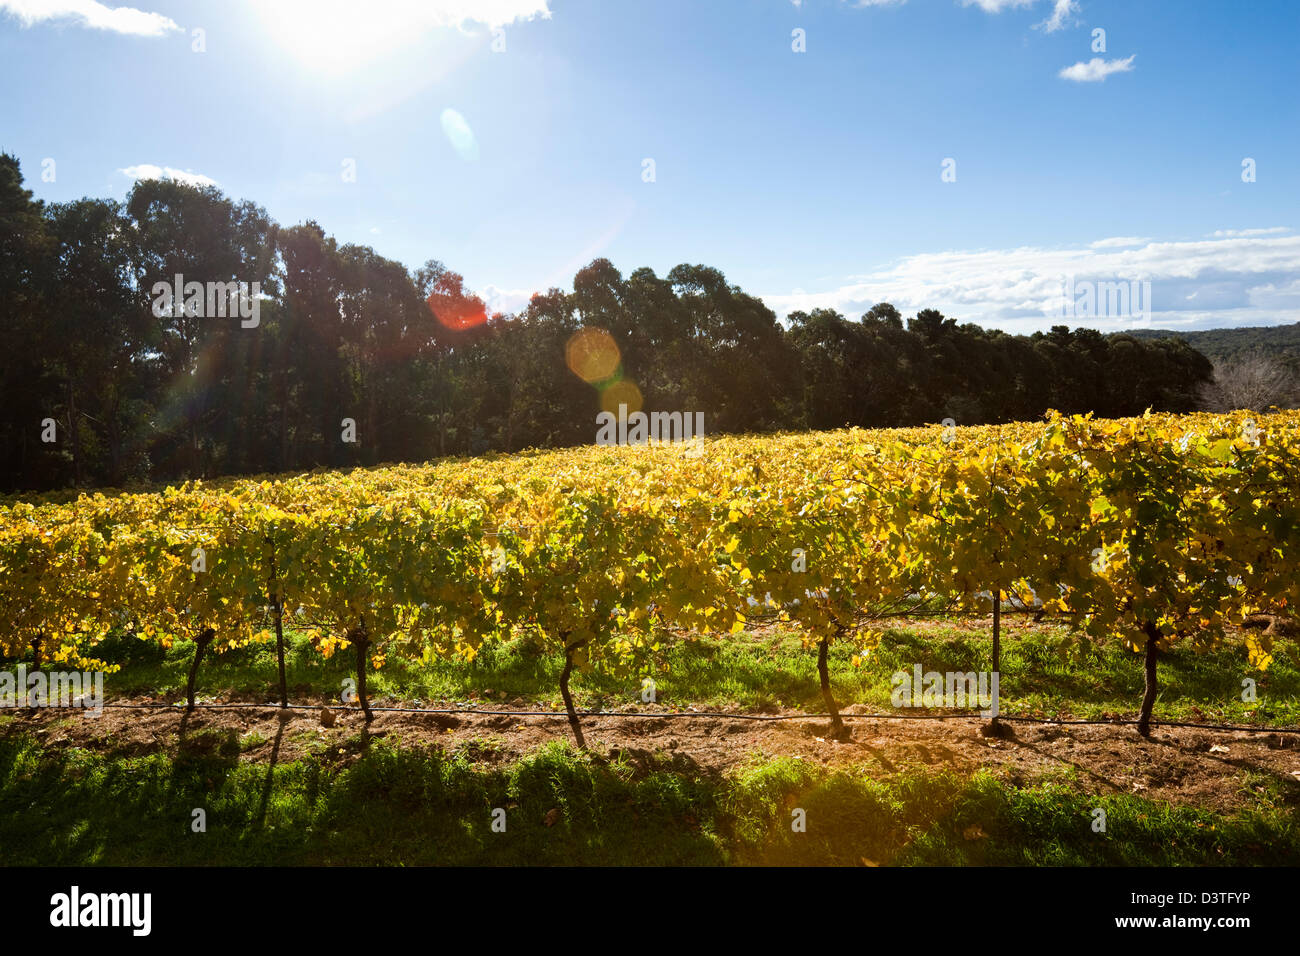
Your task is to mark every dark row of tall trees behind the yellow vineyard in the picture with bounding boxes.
[0,156,1212,490]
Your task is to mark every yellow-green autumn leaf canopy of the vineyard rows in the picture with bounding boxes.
[0,412,1300,728]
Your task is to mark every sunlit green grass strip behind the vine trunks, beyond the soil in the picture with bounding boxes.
[58,620,1300,726]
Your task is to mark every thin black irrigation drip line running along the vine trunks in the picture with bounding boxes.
[83,701,1300,734]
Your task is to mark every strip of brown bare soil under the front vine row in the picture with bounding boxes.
[10,697,1300,813]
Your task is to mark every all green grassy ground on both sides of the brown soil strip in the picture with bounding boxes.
[0,619,1300,865]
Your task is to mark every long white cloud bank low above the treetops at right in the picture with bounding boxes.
[762,235,1300,332]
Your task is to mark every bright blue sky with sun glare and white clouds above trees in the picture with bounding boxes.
[0,0,1300,333]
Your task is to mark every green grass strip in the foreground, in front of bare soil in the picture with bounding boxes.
[0,734,1300,866]
